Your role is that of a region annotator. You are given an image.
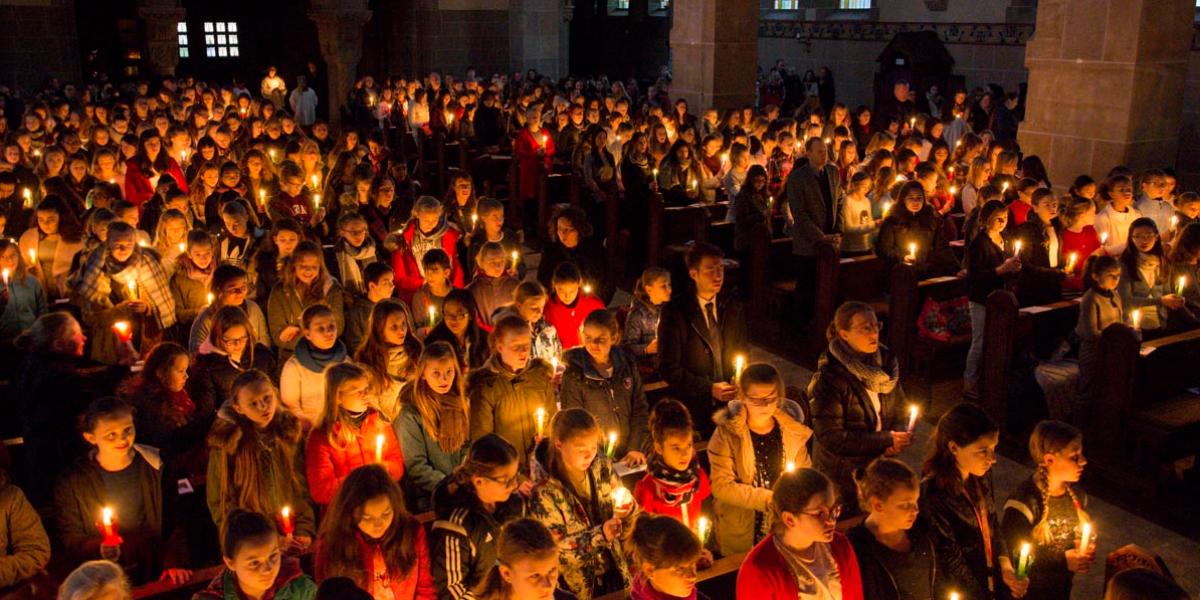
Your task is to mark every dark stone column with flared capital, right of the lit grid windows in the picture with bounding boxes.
[308,0,371,125]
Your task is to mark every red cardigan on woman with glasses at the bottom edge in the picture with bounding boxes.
[737,533,864,600]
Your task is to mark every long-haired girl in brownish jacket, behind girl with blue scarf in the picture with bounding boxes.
[266,240,346,364]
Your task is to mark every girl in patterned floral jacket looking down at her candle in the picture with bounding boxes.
[529,408,637,600]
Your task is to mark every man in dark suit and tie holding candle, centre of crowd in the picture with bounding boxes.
[658,242,748,439]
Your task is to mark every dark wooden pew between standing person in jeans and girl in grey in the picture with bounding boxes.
[979,290,1079,445]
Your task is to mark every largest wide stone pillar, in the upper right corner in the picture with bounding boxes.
[1019,0,1195,188]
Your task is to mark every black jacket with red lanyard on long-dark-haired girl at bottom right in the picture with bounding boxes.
[920,478,1012,600]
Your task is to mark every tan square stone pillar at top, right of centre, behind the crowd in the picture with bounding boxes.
[671,0,758,114]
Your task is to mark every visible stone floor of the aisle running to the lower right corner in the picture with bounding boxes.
[750,347,1200,600]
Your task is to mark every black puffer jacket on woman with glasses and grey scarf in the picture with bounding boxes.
[808,344,908,506]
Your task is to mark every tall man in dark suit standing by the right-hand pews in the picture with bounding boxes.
[784,137,841,334]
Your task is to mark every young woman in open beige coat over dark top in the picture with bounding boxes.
[708,362,812,556]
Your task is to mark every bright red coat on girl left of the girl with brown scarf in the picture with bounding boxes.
[305,410,404,505]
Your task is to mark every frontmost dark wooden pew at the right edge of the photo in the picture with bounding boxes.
[1085,324,1200,493]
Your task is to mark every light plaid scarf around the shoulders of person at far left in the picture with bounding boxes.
[74,248,175,329]
